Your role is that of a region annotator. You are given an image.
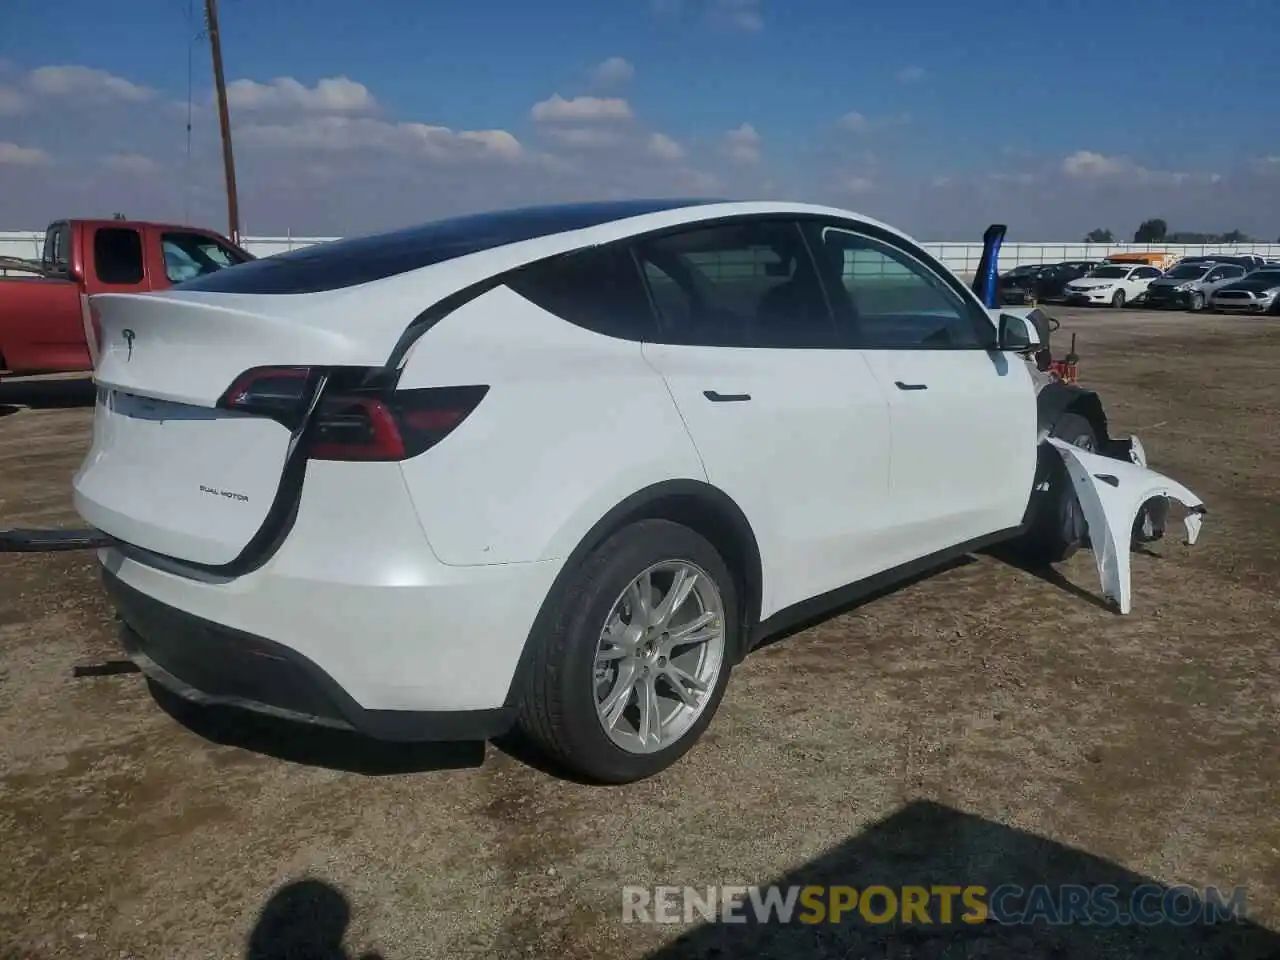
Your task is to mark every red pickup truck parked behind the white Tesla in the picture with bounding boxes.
[0,220,253,374]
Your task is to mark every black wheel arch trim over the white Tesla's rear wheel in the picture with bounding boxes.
[496,480,763,705]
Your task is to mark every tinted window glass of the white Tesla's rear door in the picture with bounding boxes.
[635,220,835,348]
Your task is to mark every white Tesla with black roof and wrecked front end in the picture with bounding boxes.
[0,201,1199,782]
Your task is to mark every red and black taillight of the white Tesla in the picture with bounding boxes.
[218,367,489,461]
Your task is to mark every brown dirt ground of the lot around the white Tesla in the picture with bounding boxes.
[0,310,1280,960]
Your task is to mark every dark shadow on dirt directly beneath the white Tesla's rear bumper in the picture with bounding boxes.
[147,681,485,777]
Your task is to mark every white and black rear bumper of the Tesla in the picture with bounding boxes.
[100,462,563,739]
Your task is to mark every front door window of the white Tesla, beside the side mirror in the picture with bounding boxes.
[809,224,993,349]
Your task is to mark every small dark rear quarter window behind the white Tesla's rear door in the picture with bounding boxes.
[507,246,655,340]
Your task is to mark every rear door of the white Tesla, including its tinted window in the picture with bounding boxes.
[634,218,892,617]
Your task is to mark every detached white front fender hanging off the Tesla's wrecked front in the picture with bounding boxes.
[1048,436,1206,613]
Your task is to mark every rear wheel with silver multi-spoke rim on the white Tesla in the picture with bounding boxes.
[517,520,741,783]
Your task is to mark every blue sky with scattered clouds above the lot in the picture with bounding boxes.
[0,0,1280,239]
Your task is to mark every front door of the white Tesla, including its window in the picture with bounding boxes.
[806,220,1037,563]
